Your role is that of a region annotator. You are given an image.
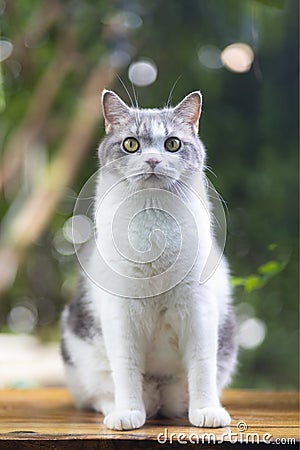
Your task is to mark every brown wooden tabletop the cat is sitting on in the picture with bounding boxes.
[0,388,299,450]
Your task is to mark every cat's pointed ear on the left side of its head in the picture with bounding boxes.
[102,89,130,133]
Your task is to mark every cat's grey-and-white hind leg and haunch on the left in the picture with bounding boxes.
[61,280,114,414]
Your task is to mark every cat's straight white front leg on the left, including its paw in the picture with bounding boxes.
[102,296,146,430]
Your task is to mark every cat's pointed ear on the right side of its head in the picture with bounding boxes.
[174,91,202,134]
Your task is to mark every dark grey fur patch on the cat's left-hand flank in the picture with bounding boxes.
[67,276,102,341]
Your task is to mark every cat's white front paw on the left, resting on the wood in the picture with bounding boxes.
[103,409,146,430]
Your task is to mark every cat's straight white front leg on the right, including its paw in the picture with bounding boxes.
[182,293,230,428]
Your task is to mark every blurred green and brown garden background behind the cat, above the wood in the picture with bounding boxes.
[0,0,299,389]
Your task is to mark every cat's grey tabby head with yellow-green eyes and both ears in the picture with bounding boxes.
[99,90,205,189]
